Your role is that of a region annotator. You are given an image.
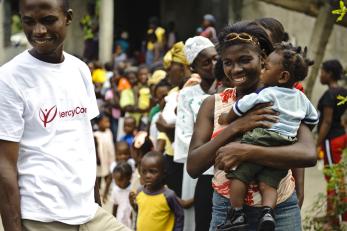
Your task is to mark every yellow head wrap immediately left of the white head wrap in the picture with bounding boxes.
[163,42,188,69]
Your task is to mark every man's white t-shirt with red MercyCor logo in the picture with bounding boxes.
[0,51,99,224]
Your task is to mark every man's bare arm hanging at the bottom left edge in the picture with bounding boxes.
[0,140,22,231]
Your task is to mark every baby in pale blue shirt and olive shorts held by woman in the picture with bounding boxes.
[218,42,318,231]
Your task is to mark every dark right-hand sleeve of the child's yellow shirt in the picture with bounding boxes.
[164,188,184,231]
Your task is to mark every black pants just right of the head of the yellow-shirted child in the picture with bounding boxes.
[164,154,183,198]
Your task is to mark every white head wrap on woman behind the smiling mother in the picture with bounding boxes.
[184,36,214,64]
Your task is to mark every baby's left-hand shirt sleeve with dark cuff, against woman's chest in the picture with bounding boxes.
[233,90,270,116]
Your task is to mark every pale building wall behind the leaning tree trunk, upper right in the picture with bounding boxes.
[242,0,347,105]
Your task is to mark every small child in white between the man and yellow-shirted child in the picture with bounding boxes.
[112,161,132,228]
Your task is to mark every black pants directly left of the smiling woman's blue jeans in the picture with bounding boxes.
[194,175,213,231]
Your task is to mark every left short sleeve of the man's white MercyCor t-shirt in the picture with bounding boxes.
[0,80,24,142]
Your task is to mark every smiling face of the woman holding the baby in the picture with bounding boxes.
[221,44,262,94]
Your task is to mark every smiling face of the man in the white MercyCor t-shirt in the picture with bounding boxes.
[20,0,72,61]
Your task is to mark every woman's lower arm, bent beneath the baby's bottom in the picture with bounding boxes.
[216,124,317,171]
